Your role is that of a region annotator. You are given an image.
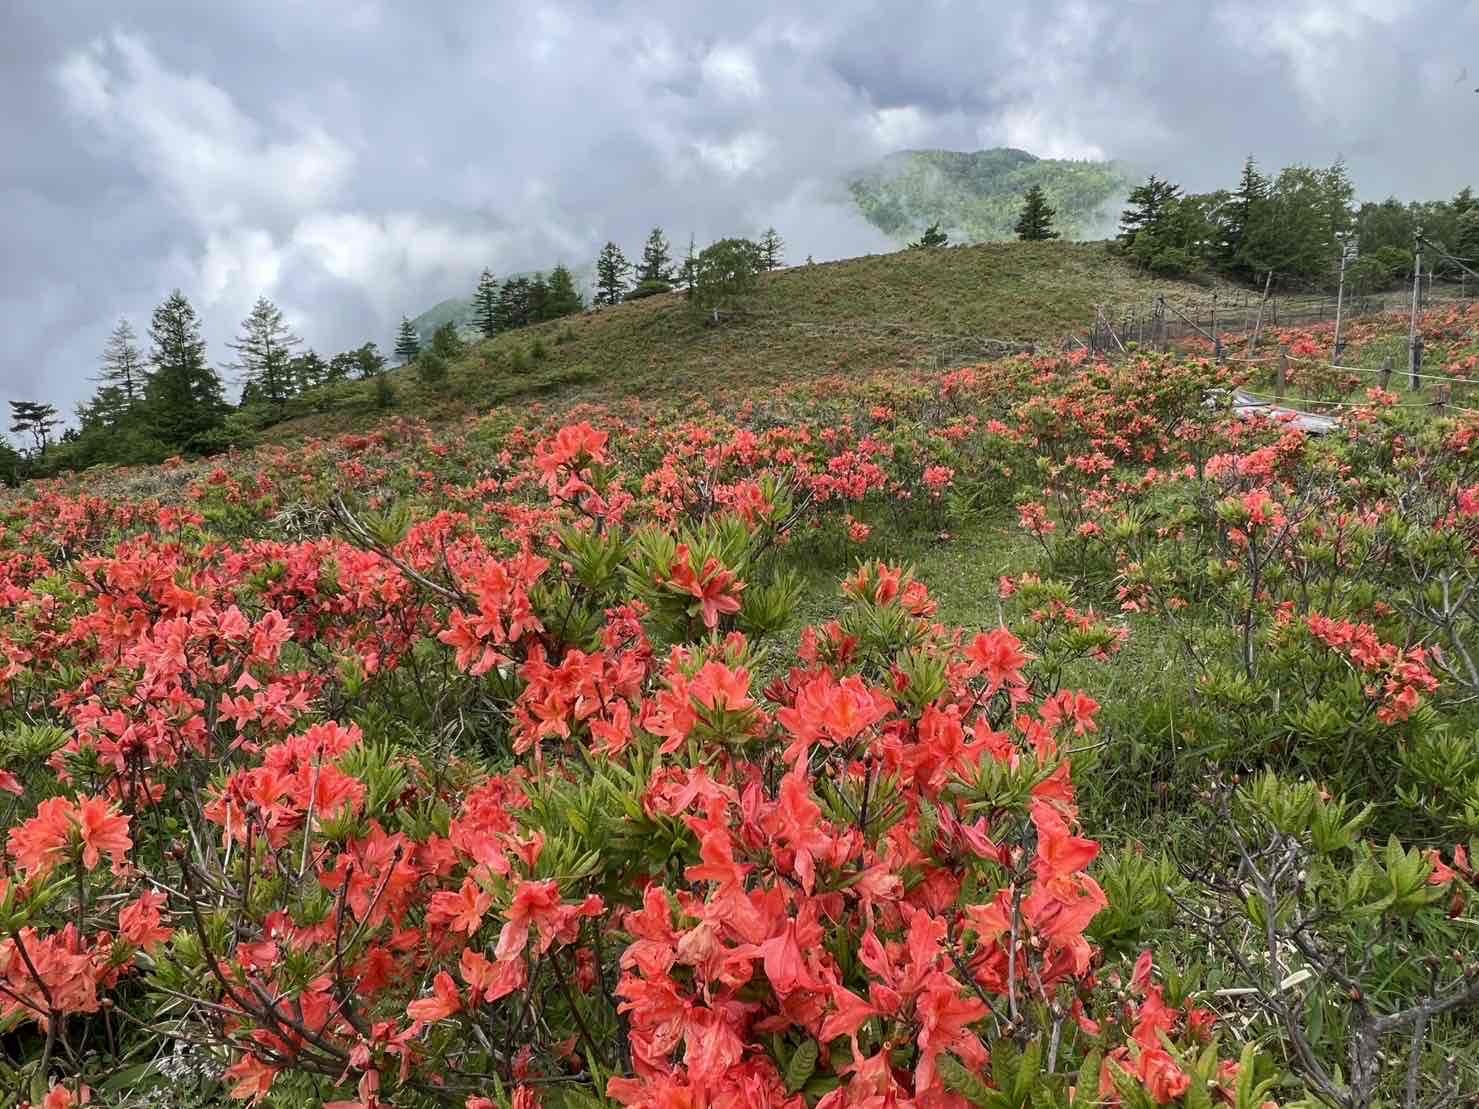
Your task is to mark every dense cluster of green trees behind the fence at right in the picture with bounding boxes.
[1117,155,1479,288]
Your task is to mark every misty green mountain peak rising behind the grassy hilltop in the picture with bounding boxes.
[847,146,1137,243]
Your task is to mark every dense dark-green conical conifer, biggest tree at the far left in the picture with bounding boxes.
[145,288,228,450]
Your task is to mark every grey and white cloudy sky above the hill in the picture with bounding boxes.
[0,0,1479,411]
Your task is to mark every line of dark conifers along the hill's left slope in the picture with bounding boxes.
[0,220,804,482]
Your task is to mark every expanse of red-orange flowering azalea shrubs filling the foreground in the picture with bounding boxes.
[0,309,1479,1109]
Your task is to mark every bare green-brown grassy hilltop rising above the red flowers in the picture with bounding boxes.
[268,243,1212,439]
